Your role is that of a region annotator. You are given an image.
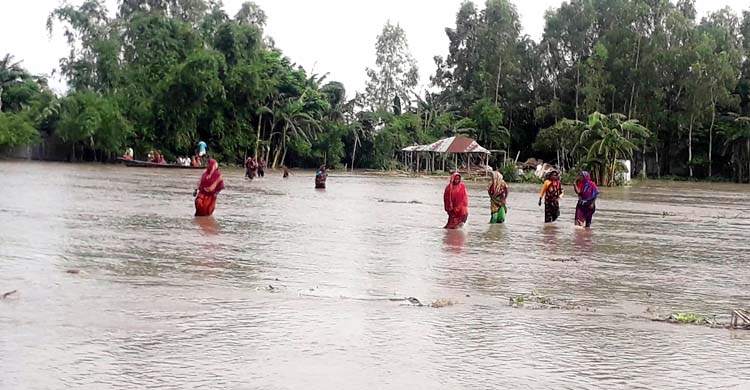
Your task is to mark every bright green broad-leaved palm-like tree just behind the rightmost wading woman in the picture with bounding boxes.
[579,112,651,186]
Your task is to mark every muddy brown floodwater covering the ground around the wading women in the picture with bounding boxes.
[0,162,750,389]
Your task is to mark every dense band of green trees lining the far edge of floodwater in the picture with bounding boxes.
[0,0,750,183]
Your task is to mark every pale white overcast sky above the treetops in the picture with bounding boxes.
[0,0,750,97]
